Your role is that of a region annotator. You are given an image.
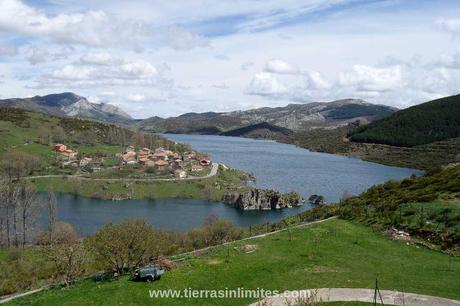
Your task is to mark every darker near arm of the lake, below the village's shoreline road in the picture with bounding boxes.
[46,193,307,235]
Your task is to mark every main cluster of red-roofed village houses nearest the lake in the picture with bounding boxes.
[117,146,211,178]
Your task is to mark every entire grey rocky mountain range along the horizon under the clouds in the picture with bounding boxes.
[0,92,397,138]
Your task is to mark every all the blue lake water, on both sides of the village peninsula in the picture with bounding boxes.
[48,135,420,235]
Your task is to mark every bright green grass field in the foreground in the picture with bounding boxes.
[8,220,460,305]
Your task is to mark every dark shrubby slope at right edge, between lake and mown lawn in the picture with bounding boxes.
[339,166,460,251]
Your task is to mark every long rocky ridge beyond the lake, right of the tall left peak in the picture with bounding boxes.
[137,99,397,138]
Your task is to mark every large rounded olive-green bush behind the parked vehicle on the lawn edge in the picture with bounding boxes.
[85,220,161,274]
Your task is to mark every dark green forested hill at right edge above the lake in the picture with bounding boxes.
[350,95,460,147]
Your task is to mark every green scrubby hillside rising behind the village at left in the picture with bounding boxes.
[0,107,189,174]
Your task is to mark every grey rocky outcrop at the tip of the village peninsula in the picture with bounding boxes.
[223,188,303,210]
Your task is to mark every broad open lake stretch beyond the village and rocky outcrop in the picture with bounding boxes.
[165,134,421,202]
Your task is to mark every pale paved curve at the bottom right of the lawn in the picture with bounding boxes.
[250,288,460,306]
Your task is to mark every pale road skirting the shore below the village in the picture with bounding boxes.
[24,163,219,182]
